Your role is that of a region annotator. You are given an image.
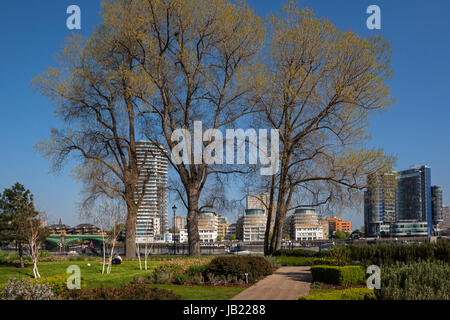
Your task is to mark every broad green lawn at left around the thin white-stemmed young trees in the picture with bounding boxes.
[0,261,164,288]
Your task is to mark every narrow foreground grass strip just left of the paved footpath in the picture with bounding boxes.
[151,284,245,300]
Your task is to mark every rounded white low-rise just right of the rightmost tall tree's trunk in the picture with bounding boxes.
[286,208,328,241]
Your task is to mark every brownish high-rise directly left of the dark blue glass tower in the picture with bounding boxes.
[364,172,397,236]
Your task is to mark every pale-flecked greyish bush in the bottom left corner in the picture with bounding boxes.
[1,278,55,300]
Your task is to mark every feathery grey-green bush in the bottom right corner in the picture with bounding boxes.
[375,261,450,300]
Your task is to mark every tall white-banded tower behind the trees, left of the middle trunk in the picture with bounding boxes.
[135,141,168,243]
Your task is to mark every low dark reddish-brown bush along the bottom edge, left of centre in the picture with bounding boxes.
[62,283,181,300]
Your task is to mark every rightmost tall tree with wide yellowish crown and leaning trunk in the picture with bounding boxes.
[257,1,393,253]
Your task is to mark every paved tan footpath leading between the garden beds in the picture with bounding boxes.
[231,267,312,300]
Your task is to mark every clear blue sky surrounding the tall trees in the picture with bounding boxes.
[0,0,450,228]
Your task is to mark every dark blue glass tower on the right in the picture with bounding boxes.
[397,166,433,236]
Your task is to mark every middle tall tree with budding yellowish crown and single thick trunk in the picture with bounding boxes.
[98,0,264,255]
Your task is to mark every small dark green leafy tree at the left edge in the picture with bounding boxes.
[0,182,38,268]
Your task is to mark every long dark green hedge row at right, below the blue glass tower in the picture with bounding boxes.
[349,240,450,266]
